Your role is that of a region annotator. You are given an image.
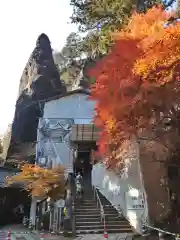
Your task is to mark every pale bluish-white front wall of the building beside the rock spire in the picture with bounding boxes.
[37,93,95,172]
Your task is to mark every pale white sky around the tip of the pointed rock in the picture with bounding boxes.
[0,0,76,134]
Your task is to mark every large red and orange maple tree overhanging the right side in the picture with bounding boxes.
[90,6,180,170]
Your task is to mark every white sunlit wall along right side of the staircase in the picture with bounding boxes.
[92,141,148,232]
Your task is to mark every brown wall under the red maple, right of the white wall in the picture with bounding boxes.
[140,145,169,222]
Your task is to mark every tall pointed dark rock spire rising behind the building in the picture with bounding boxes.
[11,34,66,144]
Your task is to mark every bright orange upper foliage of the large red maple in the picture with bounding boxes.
[115,7,180,77]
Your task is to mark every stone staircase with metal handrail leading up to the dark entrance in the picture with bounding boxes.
[75,190,132,235]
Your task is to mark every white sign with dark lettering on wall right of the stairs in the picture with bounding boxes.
[126,189,145,210]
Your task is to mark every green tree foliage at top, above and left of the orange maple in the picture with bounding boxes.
[70,0,175,55]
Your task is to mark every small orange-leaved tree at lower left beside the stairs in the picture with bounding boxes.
[6,164,65,200]
